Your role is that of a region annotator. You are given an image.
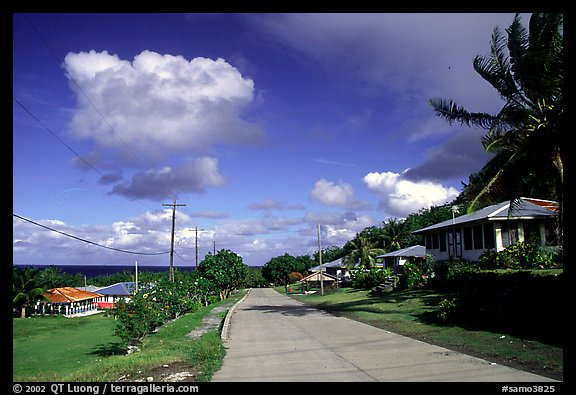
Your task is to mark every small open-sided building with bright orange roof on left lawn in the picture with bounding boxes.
[34,287,103,317]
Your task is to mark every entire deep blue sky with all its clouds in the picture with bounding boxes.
[13,13,529,266]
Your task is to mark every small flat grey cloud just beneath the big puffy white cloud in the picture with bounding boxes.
[110,157,225,200]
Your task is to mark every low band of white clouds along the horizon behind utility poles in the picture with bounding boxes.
[13,209,377,265]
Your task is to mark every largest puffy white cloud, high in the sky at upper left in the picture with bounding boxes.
[63,50,264,159]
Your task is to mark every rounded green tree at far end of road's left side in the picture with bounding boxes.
[198,249,248,300]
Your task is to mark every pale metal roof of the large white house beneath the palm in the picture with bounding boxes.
[412,197,558,234]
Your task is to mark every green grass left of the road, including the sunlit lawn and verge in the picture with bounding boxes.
[13,292,244,382]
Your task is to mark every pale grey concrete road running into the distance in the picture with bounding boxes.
[212,288,554,382]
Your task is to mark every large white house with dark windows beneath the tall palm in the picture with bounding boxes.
[412,197,558,261]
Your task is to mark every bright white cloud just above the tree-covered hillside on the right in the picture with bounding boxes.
[362,171,459,217]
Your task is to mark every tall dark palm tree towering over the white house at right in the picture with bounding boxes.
[430,13,567,241]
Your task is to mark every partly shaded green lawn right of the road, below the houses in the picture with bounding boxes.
[288,287,563,380]
